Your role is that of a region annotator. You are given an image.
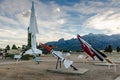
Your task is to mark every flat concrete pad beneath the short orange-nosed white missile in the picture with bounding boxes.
[47,68,88,74]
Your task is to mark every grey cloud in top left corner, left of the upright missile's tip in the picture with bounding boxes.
[0,0,31,16]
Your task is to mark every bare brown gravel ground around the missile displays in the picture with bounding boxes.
[0,54,120,80]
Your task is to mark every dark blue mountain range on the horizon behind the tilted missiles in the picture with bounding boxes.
[46,33,120,51]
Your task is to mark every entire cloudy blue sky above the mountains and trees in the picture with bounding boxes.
[0,0,120,48]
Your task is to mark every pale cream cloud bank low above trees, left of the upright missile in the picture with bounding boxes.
[0,29,27,48]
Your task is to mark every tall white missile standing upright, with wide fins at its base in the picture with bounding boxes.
[25,2,42,61]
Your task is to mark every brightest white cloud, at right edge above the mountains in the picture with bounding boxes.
[85,11,120,34]
